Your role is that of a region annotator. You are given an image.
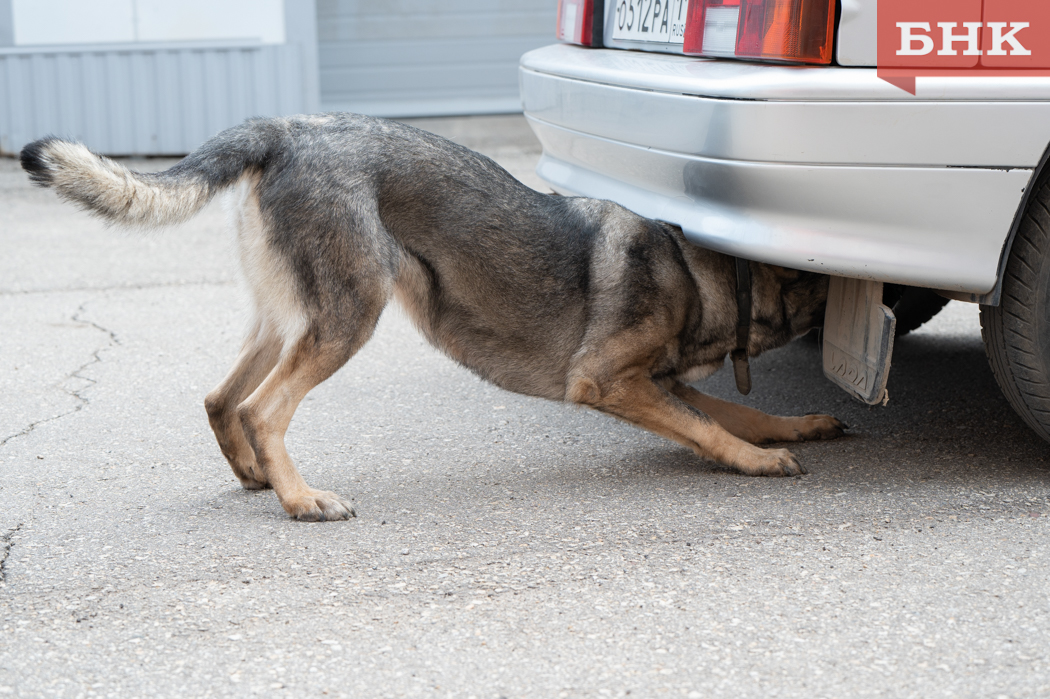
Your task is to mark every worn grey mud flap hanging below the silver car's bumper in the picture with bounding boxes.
[824,277,897,405]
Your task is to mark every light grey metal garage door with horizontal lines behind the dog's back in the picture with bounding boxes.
[317,0,558,117]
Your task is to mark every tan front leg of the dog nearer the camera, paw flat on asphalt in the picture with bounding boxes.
[569,369,805,475]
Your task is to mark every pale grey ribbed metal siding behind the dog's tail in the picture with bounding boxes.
[0,42,317,155]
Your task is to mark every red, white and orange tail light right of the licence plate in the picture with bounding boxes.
[680,0,835,64]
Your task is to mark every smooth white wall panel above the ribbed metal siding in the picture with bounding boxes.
[12,0,285,46]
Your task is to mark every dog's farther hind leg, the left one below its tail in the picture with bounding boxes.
[205,319,281,490]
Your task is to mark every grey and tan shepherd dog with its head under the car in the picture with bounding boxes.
[21,113,845,521]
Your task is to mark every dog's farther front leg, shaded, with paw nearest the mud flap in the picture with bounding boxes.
[663,379,846,444]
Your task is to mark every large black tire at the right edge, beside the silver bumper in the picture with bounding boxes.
[981,172,1050,442]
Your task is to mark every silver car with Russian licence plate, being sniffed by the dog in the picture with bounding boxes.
[520,0,1050,441]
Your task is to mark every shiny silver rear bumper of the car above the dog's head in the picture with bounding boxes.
[520,45,1050,294]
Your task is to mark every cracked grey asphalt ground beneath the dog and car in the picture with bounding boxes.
[0,118,1050,699]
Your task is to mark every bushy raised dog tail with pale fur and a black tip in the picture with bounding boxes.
[21,120,281,228]
